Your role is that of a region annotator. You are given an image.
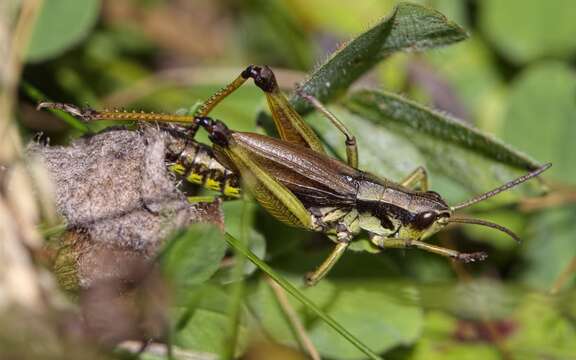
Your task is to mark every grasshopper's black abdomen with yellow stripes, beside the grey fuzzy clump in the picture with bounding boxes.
[167,141,241,198]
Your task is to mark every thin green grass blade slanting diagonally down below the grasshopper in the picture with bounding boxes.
[225,234,382,359]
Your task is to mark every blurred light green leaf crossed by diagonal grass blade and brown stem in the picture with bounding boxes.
[253,280,422,359]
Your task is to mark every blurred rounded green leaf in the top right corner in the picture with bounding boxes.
[478,0,576,63]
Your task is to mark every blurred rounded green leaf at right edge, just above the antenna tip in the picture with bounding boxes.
[502,62,576,183]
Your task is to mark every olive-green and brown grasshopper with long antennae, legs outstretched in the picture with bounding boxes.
[39,65,551,285]
